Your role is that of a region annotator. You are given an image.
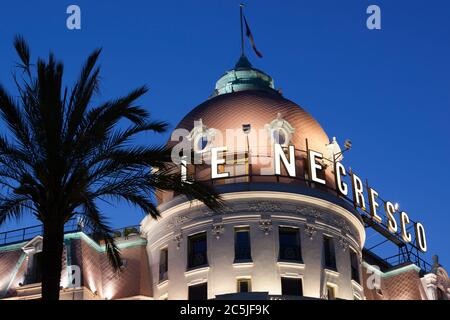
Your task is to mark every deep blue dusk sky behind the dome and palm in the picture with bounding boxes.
[0,0,450,268]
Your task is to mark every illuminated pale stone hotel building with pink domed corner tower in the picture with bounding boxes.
[0,56,450,300]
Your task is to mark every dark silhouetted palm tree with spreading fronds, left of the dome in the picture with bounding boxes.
[0,36,222,300]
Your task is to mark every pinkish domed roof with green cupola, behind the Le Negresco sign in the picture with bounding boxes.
[160,56,334,202]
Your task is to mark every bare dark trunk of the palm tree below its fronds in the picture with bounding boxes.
[42,221,64,300]
